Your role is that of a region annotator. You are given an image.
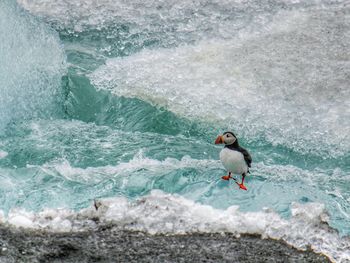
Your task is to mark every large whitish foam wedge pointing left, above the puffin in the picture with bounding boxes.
[91,7,350,157]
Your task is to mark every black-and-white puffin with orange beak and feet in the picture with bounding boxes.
[215,131,252,190]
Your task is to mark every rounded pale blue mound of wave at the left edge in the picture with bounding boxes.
[0,0,65,130]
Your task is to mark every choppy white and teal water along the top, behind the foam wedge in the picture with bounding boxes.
[18,0,341,59]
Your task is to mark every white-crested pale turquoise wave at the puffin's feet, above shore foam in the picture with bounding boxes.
[41,157,350,235]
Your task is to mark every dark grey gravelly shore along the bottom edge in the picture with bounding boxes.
[0,224,331,263]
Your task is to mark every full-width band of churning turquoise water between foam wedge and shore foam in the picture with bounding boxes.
[0,120,350,235]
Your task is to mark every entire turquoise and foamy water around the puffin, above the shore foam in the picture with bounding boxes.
[0,0,350,239]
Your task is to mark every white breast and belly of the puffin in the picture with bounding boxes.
[220,148,248,174]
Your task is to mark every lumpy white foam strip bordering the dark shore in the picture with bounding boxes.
[2,190,350,262]
